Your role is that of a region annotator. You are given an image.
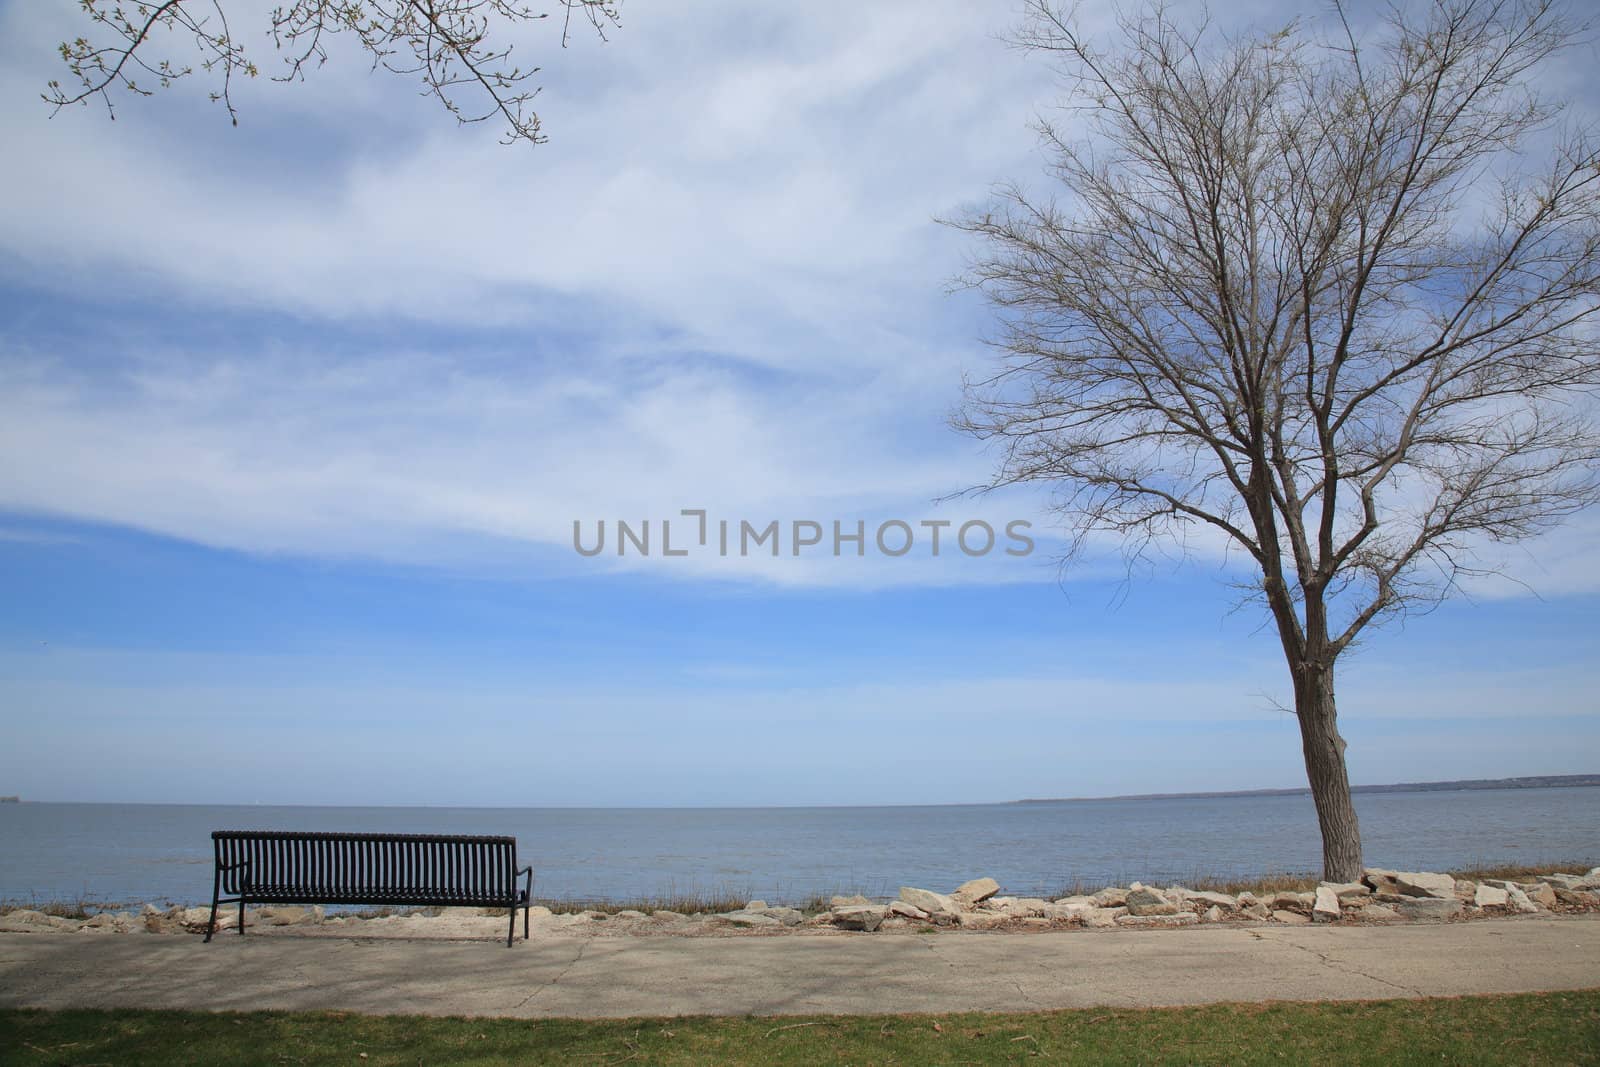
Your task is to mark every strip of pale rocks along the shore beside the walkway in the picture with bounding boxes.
[0,867,1600,937]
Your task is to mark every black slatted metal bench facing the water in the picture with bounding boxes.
[205,830,533,947]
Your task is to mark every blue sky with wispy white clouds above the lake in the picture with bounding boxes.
[0,0,1600,806]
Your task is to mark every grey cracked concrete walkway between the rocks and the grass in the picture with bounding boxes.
[0,917,1600,1017]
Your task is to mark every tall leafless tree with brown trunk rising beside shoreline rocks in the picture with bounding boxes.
[957,0,1600,881]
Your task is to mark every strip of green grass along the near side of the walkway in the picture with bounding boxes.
[0,990,1600,1067]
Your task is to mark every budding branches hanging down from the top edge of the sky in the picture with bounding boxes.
[43,0,621,144]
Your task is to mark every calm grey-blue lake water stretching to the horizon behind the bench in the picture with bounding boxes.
[0,787,1600,902]
